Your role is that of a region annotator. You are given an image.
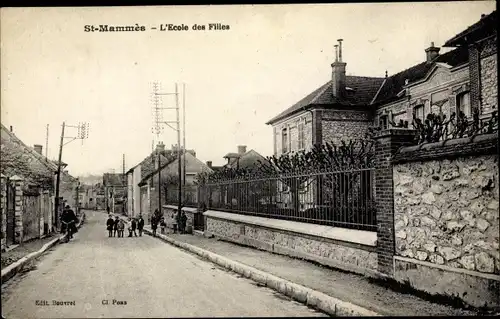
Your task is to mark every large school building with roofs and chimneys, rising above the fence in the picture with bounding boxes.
[266,11,497,156]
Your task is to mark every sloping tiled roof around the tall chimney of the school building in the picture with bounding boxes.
[266,76,384,124]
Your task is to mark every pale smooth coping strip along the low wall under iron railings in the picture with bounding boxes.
[203,210,377,247]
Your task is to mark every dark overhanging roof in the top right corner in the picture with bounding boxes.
[444,10,498,47]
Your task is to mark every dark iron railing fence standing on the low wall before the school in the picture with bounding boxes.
[200,168,377,230]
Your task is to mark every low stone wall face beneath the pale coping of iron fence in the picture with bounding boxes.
[205,213,377,276]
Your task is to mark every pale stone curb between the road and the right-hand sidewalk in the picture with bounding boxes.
[144,228,381,317]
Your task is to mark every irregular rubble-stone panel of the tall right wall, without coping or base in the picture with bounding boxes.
[393,155,500,274]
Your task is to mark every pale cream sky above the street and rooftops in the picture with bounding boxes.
[0,1,495,176]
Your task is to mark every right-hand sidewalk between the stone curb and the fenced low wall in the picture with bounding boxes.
[146,226,477,316]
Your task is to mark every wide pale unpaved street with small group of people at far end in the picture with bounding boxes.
[2,211,326,318]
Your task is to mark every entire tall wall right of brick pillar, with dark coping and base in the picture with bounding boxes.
[392,134,500,308]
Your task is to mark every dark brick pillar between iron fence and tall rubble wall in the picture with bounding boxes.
[375,128,416,277]
